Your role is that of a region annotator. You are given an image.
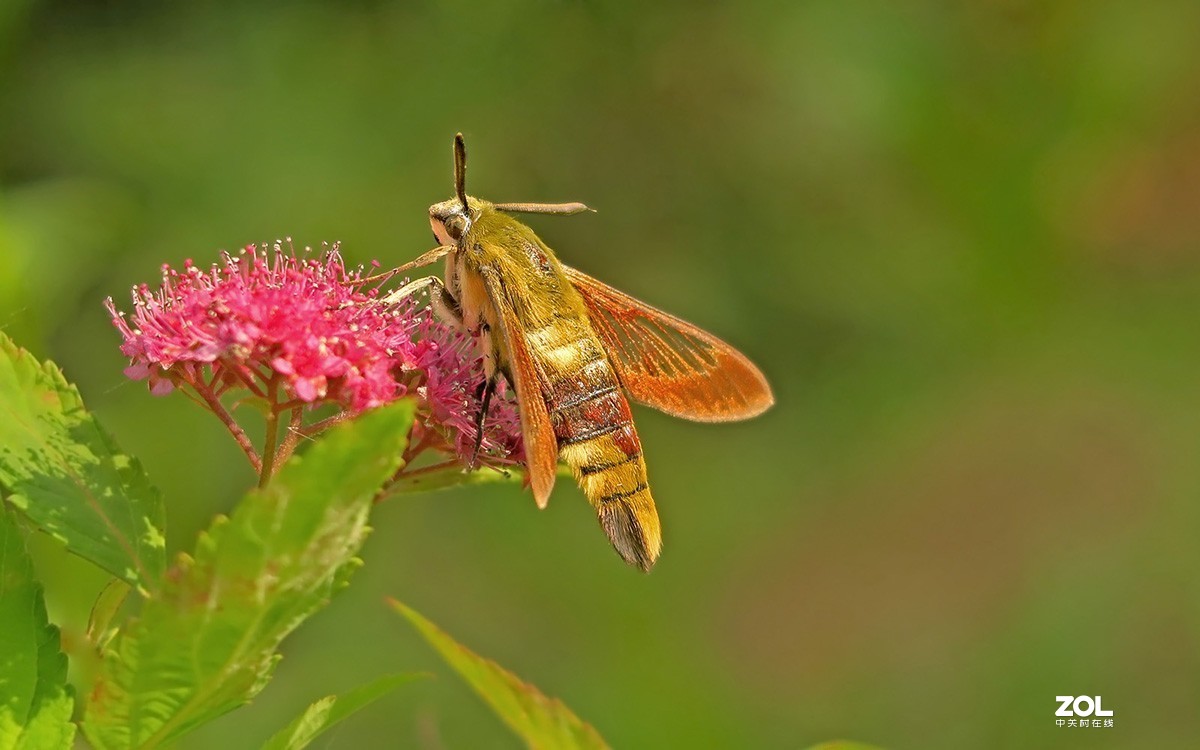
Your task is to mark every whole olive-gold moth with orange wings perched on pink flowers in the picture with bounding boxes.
[388,133,774,571]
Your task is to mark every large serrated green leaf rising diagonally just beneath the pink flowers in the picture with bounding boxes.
[84,401,413,749]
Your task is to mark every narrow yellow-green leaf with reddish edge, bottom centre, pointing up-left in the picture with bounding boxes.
[390,600,608,750]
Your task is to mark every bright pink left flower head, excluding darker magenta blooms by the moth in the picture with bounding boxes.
[107,246,393,412]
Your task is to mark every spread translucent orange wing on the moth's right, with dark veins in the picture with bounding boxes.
[563,265,775,422]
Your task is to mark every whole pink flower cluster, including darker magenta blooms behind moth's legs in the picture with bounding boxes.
[106,244,521,461]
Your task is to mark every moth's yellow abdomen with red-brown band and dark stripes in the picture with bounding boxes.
[529,319,662,570]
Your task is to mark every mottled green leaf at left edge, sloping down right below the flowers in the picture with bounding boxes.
[0,334,166,592]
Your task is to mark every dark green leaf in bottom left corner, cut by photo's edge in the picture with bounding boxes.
[0,505,74,750]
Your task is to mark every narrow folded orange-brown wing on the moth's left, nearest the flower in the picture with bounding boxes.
[481,269,558,508]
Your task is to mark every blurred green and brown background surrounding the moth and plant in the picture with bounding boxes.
[0,0,1200,749]
